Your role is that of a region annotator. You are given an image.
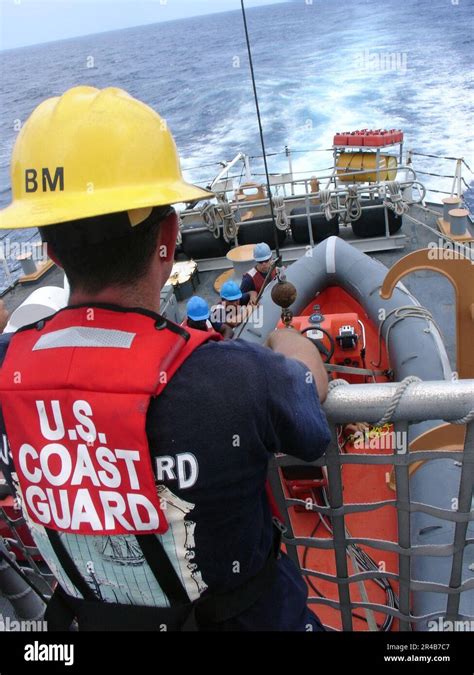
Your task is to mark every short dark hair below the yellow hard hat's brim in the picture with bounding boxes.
[40,206,172,294]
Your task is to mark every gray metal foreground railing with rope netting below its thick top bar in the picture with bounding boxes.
[270,380,474,631]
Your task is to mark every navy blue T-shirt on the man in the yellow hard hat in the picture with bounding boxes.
[0,335,330,630]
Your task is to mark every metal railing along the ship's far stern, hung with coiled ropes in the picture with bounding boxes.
[177,143,472,271]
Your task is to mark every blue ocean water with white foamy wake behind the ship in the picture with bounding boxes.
[0,0,474,289]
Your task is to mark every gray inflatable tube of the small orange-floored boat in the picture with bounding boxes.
[240,237,474,630]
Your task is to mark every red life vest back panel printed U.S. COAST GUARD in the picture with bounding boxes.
[0,306,221,535]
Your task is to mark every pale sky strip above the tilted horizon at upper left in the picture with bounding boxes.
[0,0,284,49]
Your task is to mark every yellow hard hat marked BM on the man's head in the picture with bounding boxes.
[0,87,213,229]
